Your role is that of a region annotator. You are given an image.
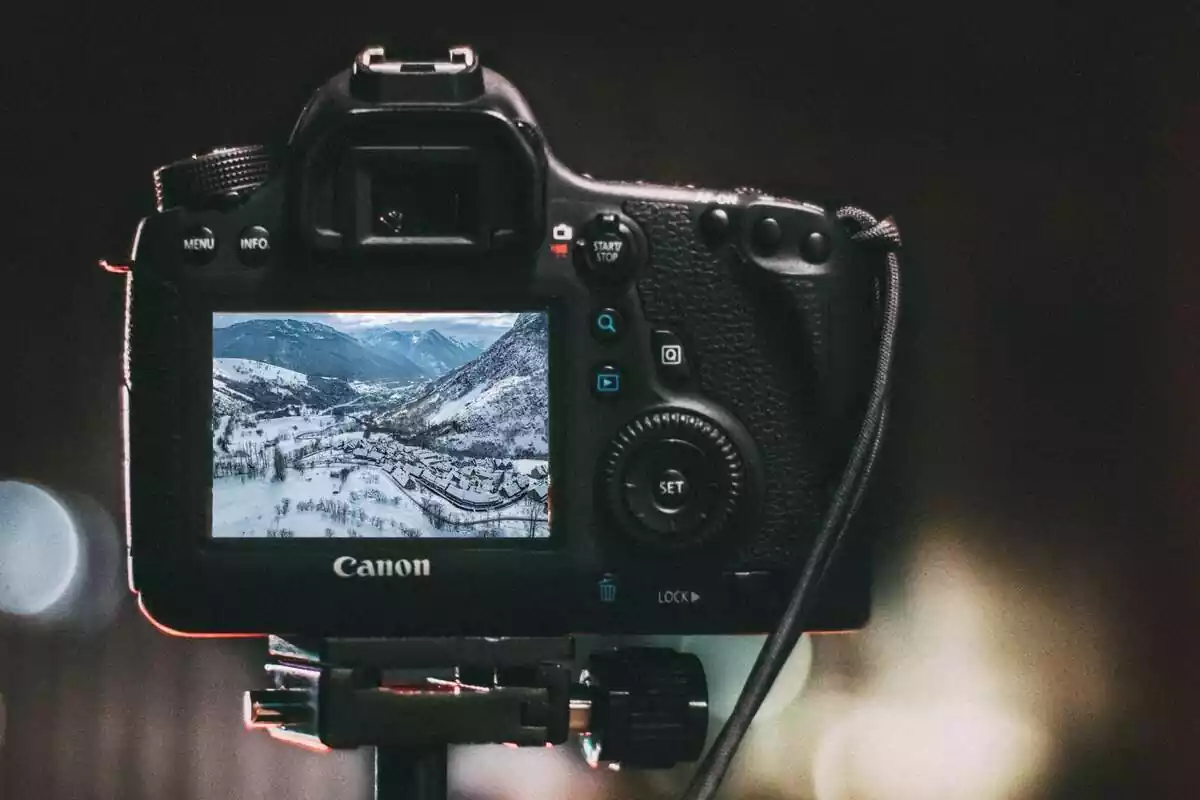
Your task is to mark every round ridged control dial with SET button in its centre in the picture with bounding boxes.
[601,409,745,551]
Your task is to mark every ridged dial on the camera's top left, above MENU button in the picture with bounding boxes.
[154,145,272,211]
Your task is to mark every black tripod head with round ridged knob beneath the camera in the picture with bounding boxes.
[244,636,708,798]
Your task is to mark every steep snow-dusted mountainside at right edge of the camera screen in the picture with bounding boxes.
[380,313,550,456]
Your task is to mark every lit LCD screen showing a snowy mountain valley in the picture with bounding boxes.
[212,311,550,539]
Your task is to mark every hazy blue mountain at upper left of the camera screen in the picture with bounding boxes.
[212,319,431,380]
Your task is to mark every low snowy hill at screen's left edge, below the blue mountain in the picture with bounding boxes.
[212,359,358,414]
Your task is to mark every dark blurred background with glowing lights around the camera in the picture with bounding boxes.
[0,2,1200,800]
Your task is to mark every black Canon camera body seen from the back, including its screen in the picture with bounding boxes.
[125,48,880,637]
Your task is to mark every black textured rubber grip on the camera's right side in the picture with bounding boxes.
[625,201,847,567]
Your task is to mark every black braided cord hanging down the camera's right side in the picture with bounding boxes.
[683,207,900,800]
